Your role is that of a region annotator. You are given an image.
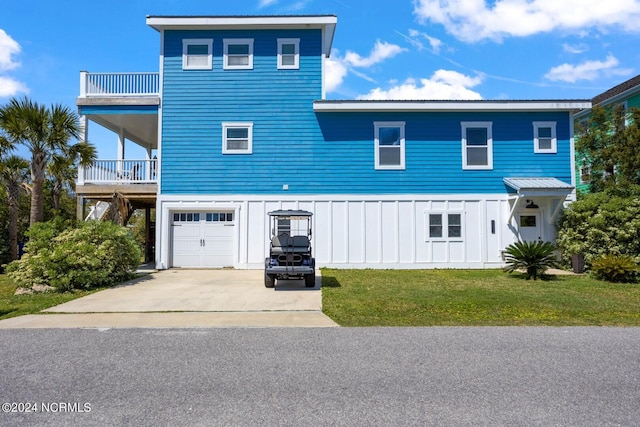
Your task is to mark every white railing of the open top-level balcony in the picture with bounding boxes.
[80,71,160,98]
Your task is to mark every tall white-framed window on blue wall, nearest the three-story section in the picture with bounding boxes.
[374,122,405,169]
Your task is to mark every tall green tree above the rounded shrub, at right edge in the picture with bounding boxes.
[576,105,640,192]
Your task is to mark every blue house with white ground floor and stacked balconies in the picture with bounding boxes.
[77,15,590,268]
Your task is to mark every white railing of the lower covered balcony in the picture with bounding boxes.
[78,159,158,185]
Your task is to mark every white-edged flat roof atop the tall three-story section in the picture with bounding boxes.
[147,15,338,57]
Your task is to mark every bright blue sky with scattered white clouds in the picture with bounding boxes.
[0,0,640,158]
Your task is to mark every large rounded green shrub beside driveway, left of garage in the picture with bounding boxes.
[7,221,141,291]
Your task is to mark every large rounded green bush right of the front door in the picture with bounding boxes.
[556,186,640,266]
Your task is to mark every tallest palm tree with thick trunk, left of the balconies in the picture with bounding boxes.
[0,97,89,224]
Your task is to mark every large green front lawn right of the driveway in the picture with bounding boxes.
[322,269,640,326]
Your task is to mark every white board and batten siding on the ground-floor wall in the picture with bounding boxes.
[156,194,540,269]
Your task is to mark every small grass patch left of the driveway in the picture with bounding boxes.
[0,274,98,320]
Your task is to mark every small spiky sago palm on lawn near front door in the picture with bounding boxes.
[505,241,558,280]
